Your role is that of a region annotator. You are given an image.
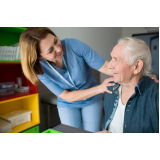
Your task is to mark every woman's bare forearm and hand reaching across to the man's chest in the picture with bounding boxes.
[59,77,114,102]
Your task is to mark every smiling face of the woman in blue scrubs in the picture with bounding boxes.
[40,33,64,62]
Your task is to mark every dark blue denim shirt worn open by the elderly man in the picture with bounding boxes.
[103,77,159,133]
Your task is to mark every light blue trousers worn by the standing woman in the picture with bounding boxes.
[58,100,103,132]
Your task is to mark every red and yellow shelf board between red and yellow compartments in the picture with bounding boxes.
[0,92,37,104]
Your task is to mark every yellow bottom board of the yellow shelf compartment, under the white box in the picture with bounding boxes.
[9,121,39,133]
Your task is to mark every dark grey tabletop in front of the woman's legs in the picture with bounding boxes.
[52,124,92,133]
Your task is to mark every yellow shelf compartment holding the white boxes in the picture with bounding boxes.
[0,93,40,133]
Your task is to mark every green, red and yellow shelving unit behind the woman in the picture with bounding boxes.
[0,27,40,133]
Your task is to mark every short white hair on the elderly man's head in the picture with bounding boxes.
[118,37,152,76]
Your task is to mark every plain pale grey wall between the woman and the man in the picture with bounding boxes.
[50,27,122,82]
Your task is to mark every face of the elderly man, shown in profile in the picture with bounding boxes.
[108,44,134,84]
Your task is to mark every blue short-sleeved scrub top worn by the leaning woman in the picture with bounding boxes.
[38,38,105,107]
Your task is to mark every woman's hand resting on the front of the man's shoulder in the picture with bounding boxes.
[98,77,114,94]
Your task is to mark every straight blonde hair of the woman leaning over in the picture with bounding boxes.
[19,27,57,85]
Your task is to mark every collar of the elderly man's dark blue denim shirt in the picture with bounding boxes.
[113,76,151,95]
